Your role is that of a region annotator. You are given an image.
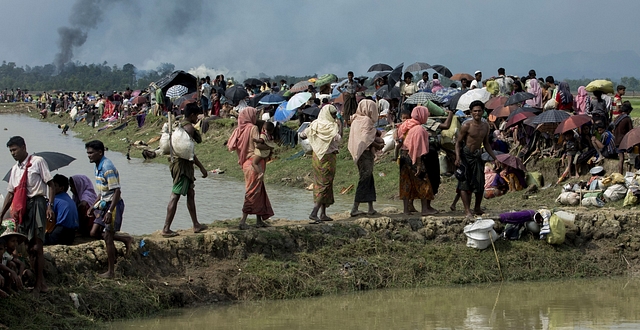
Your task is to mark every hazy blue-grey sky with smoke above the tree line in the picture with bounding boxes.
[0,0,640,78]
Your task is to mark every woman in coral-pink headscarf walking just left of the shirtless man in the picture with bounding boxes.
[398,106,437,215]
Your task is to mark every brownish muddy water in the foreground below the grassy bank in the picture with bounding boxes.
[111,278,640,330]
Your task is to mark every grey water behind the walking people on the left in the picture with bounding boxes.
[0,114,392,234]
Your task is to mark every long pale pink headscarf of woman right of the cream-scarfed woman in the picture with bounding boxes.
[347,99,378,161]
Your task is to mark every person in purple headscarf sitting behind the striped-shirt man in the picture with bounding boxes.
[69,175,98,236]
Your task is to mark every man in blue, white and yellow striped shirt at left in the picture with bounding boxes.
[84,140,133,278]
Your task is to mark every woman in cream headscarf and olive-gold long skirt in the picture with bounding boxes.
[300,105,342,224]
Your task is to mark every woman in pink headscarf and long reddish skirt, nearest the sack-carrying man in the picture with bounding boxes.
[228,107,273,230]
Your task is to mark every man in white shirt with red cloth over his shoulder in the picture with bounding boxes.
[0,136,55,296]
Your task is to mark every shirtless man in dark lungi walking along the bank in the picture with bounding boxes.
[456,101,497,220]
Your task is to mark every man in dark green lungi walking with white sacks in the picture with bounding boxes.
[162,103,207,237]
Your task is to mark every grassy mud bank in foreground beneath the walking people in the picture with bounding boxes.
[0,209,640,329]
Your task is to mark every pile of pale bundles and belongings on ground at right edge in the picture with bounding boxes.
[556,166,640,207]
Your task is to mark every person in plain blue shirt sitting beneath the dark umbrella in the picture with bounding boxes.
[44,174,79,245]
